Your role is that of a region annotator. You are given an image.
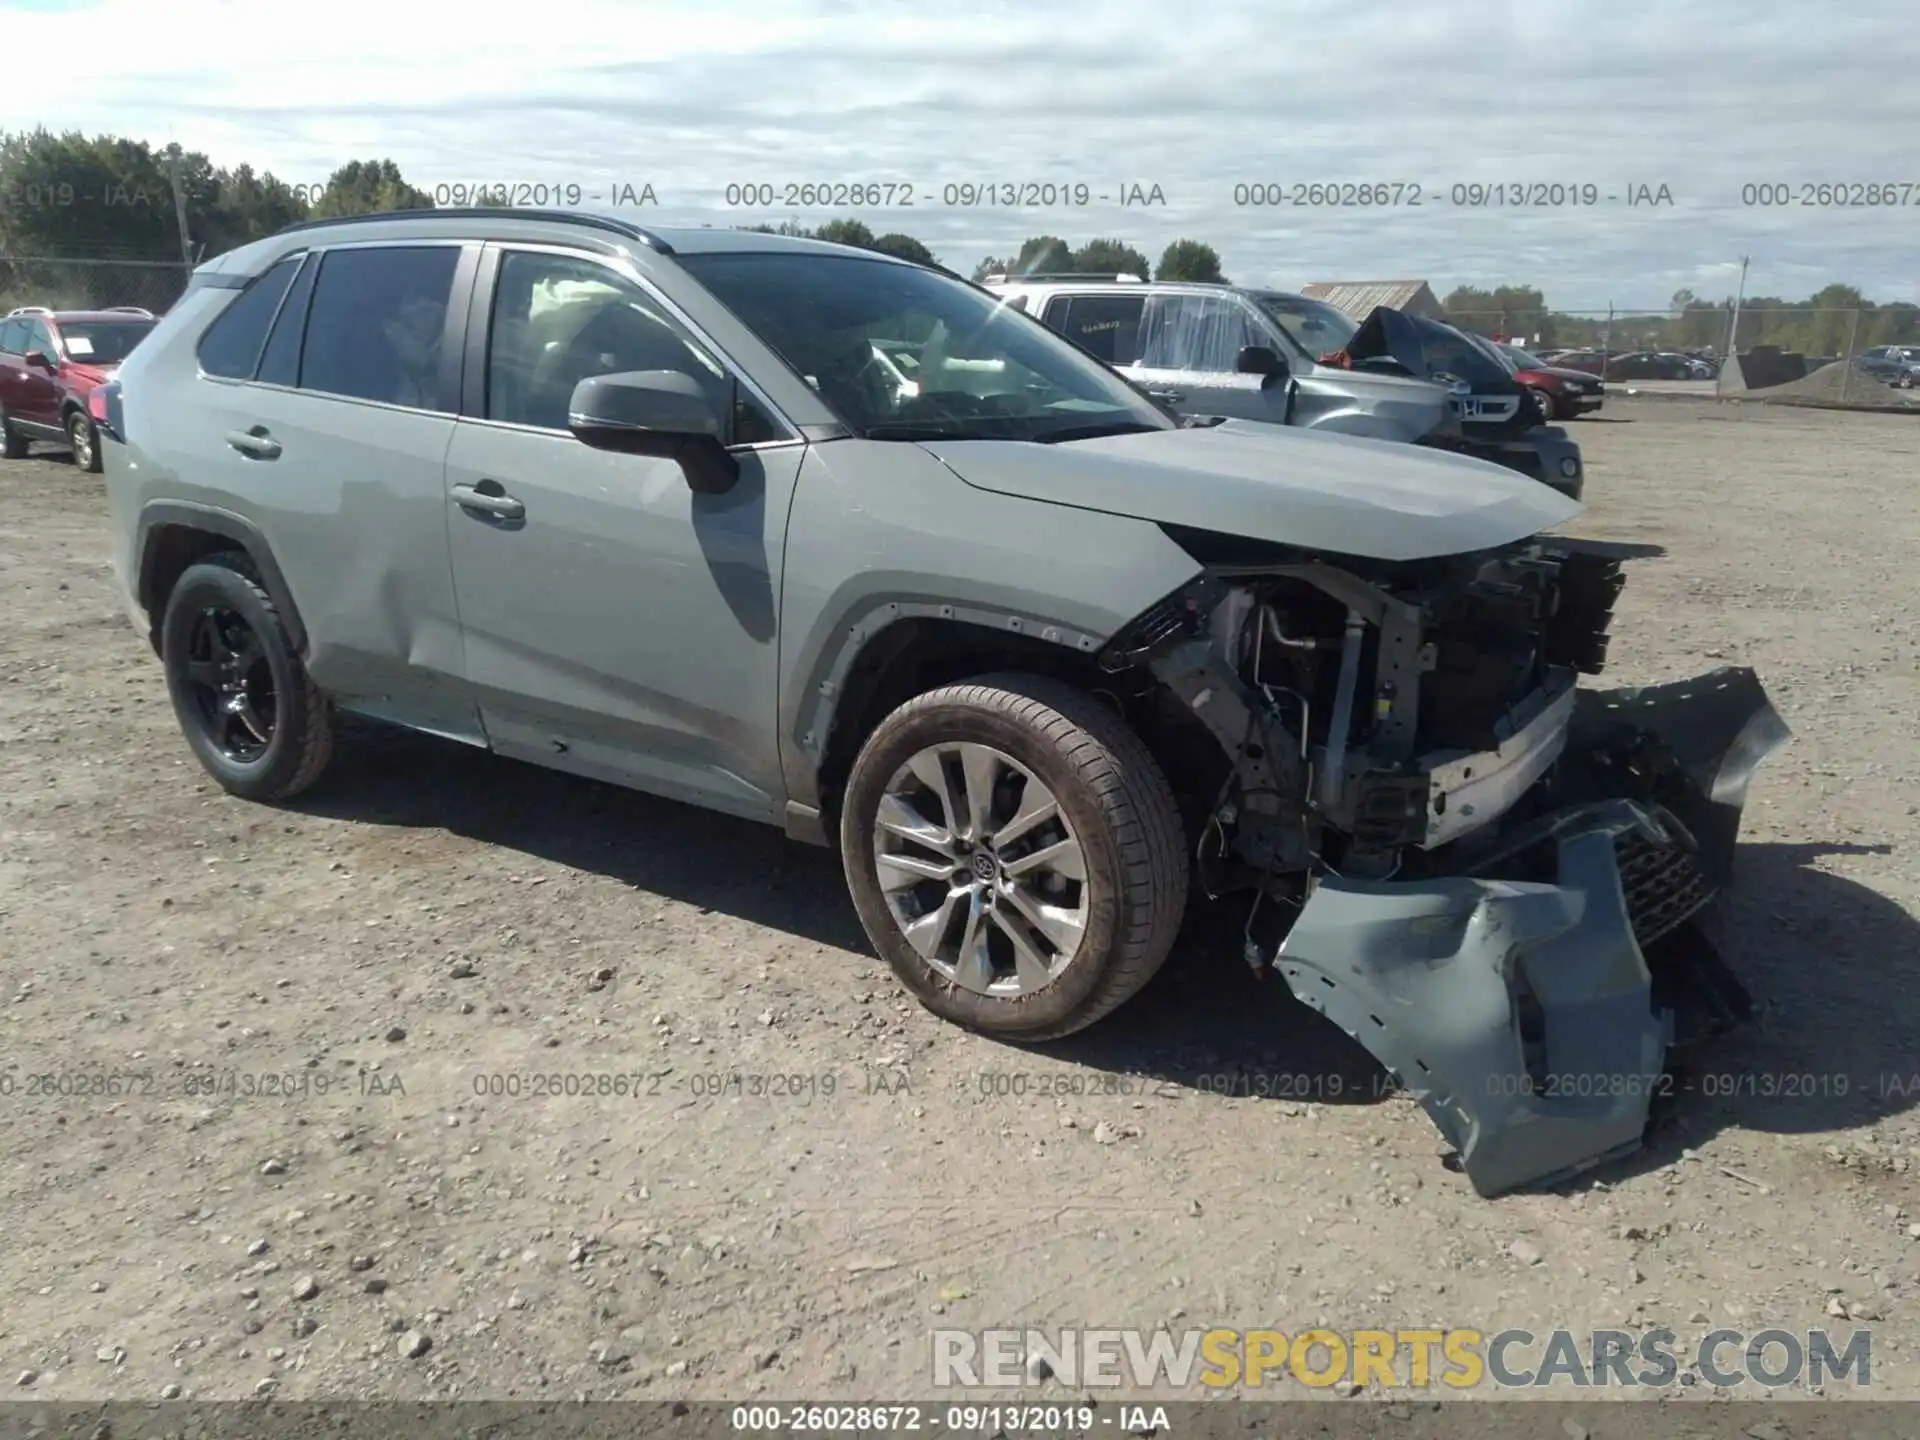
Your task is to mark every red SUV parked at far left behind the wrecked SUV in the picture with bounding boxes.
[0,305,157,470]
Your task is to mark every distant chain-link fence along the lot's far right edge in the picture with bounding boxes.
[1446,303,1920,407]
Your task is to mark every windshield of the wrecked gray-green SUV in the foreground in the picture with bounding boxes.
[678,252,1179,442]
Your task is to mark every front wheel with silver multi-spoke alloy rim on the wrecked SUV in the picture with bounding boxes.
[841,674,1188,1041]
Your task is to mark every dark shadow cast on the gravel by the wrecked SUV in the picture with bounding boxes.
[294,724,1920,1179]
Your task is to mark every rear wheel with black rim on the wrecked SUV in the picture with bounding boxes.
[159,555,334,801]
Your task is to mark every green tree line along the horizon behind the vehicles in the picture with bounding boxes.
[0,129,1920,355]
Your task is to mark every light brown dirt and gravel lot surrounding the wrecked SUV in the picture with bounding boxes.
[0,401,1920,1400]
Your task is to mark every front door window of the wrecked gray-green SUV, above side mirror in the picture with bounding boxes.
[486,250,781,445]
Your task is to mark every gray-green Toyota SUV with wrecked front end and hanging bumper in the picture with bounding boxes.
[100,211,1782,1192]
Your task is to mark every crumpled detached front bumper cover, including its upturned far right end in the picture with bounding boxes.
[1275,670,1788,1196]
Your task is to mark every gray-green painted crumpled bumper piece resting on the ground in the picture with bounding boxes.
[1279,803,1668,1196]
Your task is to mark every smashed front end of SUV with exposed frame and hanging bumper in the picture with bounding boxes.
[1100,528,1788,1194]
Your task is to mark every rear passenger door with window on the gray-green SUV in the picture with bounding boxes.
[196,242,484,743]
